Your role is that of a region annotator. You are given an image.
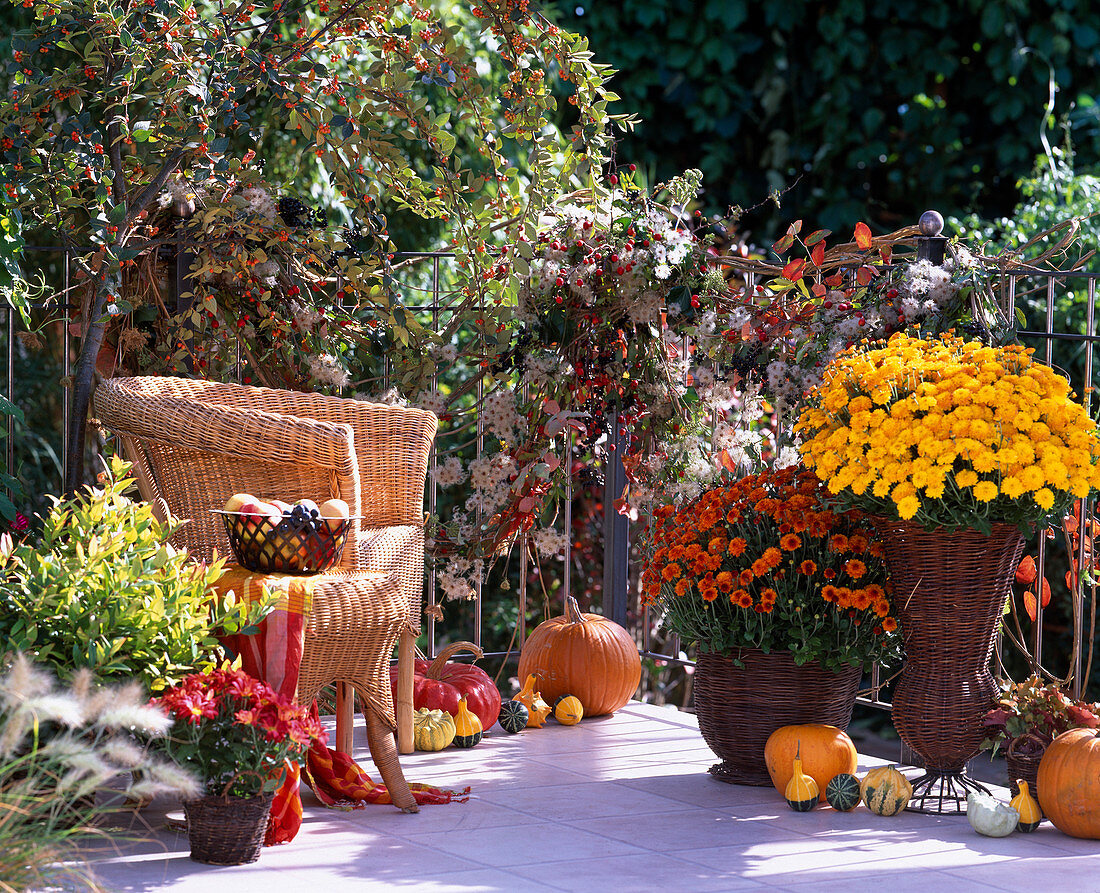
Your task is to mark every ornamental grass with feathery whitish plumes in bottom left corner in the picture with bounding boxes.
[0,655,198,891]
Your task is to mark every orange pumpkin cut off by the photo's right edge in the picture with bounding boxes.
[1037,729,1100,840]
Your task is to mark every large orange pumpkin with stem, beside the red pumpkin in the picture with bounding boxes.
[519,596,641,716]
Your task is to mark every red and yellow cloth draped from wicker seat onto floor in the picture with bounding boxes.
[216,564,470,847]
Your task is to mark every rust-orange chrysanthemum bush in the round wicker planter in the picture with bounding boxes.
[642,466,899,670]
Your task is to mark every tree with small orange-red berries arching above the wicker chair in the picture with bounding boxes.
[0,0,627,492]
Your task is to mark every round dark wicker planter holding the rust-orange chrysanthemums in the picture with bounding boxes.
[694,648,862,786]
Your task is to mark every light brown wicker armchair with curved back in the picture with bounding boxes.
[95,376,437,807]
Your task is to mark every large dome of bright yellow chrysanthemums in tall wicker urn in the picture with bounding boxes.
[795,332,1100,533]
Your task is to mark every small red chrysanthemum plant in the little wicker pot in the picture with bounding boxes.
[152,665,326,797]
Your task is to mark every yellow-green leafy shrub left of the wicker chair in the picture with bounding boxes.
[0,459,264,691]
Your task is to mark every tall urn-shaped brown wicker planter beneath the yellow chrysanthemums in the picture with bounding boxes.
[873,518,1024,775]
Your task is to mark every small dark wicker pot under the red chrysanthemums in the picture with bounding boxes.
[184,793,275,866]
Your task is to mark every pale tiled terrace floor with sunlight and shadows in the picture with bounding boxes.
[79,704,1100,893]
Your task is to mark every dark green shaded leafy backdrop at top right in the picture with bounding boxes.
[557,0,1100,236]
